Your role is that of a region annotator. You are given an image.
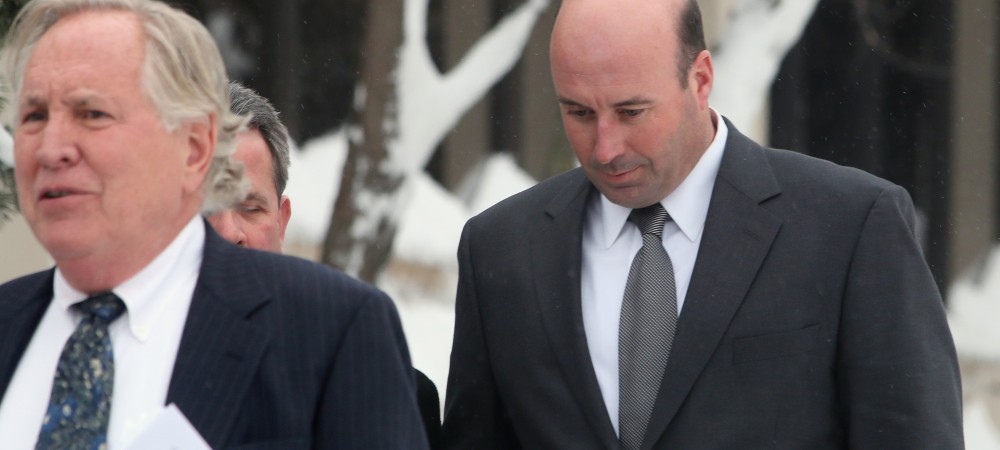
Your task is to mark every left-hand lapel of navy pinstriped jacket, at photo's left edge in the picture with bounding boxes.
[0,269,55,399]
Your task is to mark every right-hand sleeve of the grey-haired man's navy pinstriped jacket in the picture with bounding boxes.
[313,291,427,450]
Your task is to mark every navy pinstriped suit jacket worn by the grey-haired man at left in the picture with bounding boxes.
[0,224,426,449]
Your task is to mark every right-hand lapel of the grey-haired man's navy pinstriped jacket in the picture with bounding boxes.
[167,227,269,448]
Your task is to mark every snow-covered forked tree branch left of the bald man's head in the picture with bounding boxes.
[390,0,549,173]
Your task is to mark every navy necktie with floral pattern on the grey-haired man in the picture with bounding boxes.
[35,292,125,450]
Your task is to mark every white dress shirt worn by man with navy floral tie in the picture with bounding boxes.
[0,215,205,450]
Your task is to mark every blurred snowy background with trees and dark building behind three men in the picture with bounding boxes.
[0,0,1000,442]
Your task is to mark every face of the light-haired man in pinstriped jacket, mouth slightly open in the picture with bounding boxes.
[14,11,214,269]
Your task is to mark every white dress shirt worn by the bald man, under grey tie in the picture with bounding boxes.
[581,110,729,433]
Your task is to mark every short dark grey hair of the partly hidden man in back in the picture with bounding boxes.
[229,81,291,198]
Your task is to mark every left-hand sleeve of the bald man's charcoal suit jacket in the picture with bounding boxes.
[442,224,520,450]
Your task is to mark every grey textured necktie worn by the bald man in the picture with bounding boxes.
[618,203,677,450]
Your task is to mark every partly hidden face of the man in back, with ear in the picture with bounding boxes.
[208,129,292,253]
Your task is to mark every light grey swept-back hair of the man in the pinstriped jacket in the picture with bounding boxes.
[0,0,247,212]
